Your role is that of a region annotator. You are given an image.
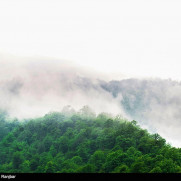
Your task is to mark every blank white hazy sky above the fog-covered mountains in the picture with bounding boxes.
[0,0,181,80]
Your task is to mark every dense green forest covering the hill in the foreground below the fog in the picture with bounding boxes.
[0,107,181,173]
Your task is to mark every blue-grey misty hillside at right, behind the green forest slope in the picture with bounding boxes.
[100,79,181,146]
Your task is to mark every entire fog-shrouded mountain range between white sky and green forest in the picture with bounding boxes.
[0,57,181,146]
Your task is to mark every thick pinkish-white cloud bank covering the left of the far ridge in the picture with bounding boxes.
[0,55,126,119]
